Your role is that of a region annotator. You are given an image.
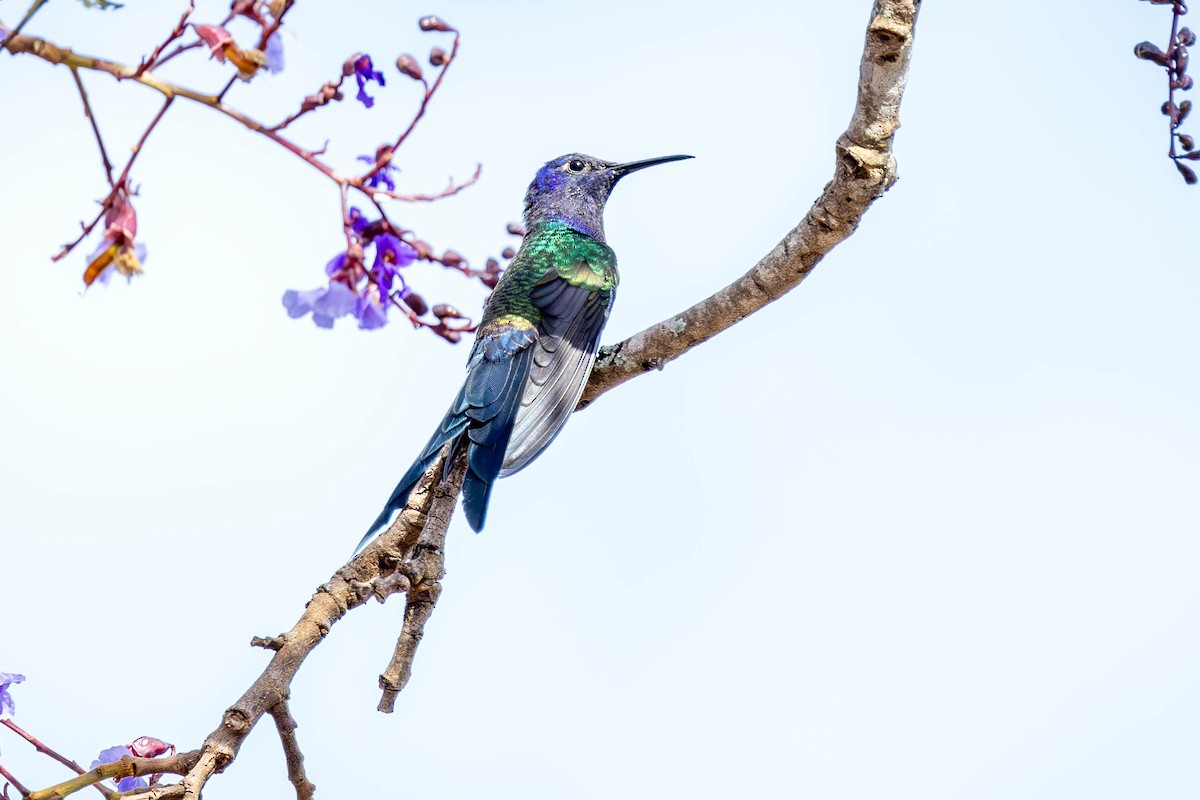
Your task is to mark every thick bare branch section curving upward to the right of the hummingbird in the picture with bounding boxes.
[578,0,920,408]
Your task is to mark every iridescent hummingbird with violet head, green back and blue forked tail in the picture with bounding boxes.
[359,152,691,549]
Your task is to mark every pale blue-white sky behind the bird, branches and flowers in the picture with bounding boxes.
[0,0,1200,800]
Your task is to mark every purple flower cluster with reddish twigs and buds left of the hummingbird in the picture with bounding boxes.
[45,6,487,342]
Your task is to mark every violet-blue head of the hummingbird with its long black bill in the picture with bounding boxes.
[524,152,691,240]
